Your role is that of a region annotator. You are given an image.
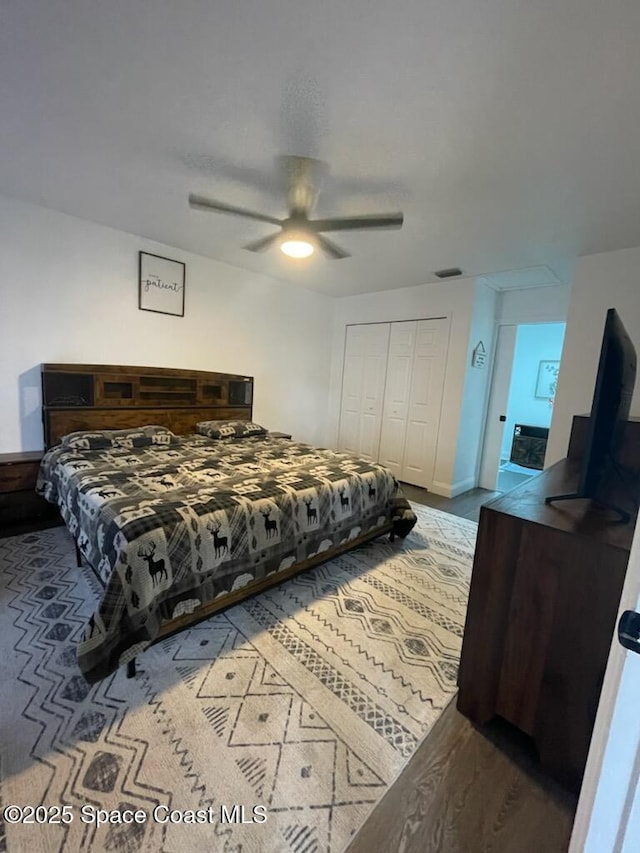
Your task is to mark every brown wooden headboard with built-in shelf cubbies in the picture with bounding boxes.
[42,364,253,448]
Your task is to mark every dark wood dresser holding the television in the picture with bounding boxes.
[458,418,640,790]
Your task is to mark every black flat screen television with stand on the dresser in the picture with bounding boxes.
[545,308,636,522]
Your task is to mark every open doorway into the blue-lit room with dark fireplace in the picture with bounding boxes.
[478,323,566,492]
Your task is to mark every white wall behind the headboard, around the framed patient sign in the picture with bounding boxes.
[0,196,333,452]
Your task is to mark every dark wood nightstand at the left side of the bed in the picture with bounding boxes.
[0,450,62,536]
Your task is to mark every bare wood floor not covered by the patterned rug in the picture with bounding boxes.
[347,485,576,853]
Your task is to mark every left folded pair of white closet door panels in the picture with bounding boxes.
[338,323,389,461]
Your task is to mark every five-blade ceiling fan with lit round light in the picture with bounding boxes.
[189,155,403,260]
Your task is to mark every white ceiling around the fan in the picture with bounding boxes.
[0,0,640,295]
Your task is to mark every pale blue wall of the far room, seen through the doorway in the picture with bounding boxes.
[501,323,565,459]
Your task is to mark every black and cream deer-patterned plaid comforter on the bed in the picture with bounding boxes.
[37,436,416,682]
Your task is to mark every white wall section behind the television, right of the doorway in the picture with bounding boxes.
[545,248,640,466]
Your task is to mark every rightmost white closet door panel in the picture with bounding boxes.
[400,319,449,489]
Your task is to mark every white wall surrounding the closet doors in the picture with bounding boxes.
[329,279,484,495]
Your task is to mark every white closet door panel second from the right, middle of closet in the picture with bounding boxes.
[380,321,418,480]
